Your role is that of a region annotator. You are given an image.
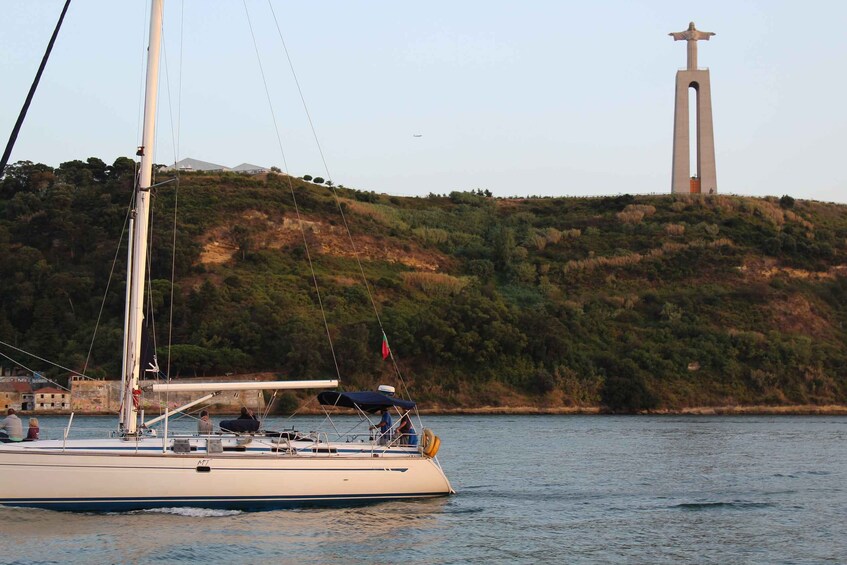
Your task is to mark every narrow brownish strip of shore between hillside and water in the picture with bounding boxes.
[26,404,847,417]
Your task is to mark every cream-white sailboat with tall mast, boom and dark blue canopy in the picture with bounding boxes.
[0,0,453,511]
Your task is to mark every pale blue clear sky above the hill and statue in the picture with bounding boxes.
[0,0,847,202]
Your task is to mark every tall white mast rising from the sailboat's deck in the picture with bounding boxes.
[121,0,164,436]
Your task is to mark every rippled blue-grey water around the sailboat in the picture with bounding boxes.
[0,416,847,564]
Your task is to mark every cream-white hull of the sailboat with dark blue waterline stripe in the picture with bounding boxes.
[0,438,452,511]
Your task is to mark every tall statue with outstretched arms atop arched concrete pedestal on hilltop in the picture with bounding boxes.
[668,22,718,194]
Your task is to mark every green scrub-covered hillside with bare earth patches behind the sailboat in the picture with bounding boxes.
[0,158,847,411]
